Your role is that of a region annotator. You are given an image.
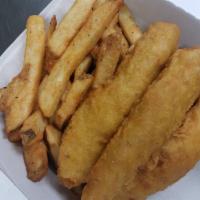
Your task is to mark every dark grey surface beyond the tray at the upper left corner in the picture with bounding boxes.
[0,0,51,55]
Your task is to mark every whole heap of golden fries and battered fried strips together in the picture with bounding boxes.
[0,0,200,200]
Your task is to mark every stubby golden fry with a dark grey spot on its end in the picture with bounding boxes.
[20,111,47,146]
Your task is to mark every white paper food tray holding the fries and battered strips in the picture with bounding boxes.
[0,0,200,200]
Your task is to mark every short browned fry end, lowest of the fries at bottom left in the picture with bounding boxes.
[23,142,48,182]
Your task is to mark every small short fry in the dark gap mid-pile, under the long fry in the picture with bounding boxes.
[74,55,92,80]
